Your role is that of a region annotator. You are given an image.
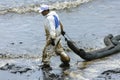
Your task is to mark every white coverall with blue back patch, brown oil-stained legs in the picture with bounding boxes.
[42,11,70,64]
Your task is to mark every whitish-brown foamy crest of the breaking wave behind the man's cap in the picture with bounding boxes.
[0,0,92,14]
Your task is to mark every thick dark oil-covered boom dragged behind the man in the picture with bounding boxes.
[67,34,120,61]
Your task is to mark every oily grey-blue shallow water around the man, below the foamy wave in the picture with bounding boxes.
[0,0,120,80]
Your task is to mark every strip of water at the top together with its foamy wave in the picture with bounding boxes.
[0,0,92,15]
